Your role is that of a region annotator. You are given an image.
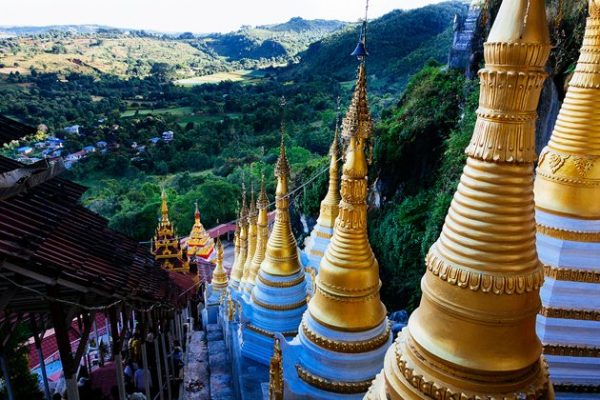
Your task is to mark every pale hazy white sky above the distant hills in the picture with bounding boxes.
[0,0,448,33]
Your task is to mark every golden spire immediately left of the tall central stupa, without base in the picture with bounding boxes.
[260,120,301,276]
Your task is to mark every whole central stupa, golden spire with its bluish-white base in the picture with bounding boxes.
[282,28,392,399]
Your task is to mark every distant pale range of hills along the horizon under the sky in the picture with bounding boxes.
[0,18,344,79]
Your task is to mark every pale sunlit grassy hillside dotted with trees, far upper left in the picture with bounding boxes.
[0,35,218,78]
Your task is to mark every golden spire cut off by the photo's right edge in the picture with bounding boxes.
[535,1,600,219]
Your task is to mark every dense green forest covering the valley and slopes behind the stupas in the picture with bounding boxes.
[0,0,586,311]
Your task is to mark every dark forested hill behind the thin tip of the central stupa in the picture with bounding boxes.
[287,2,466,87]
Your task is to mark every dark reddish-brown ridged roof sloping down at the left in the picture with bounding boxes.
[0,157,179,320]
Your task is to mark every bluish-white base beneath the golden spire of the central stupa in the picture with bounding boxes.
[280,312,392,400]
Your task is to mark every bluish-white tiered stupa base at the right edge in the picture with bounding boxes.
[536,210,600,390]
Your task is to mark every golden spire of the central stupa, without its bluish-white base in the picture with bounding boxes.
[308,56,386,331]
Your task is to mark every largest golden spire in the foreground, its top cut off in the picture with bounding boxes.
[367,0,553,399]
